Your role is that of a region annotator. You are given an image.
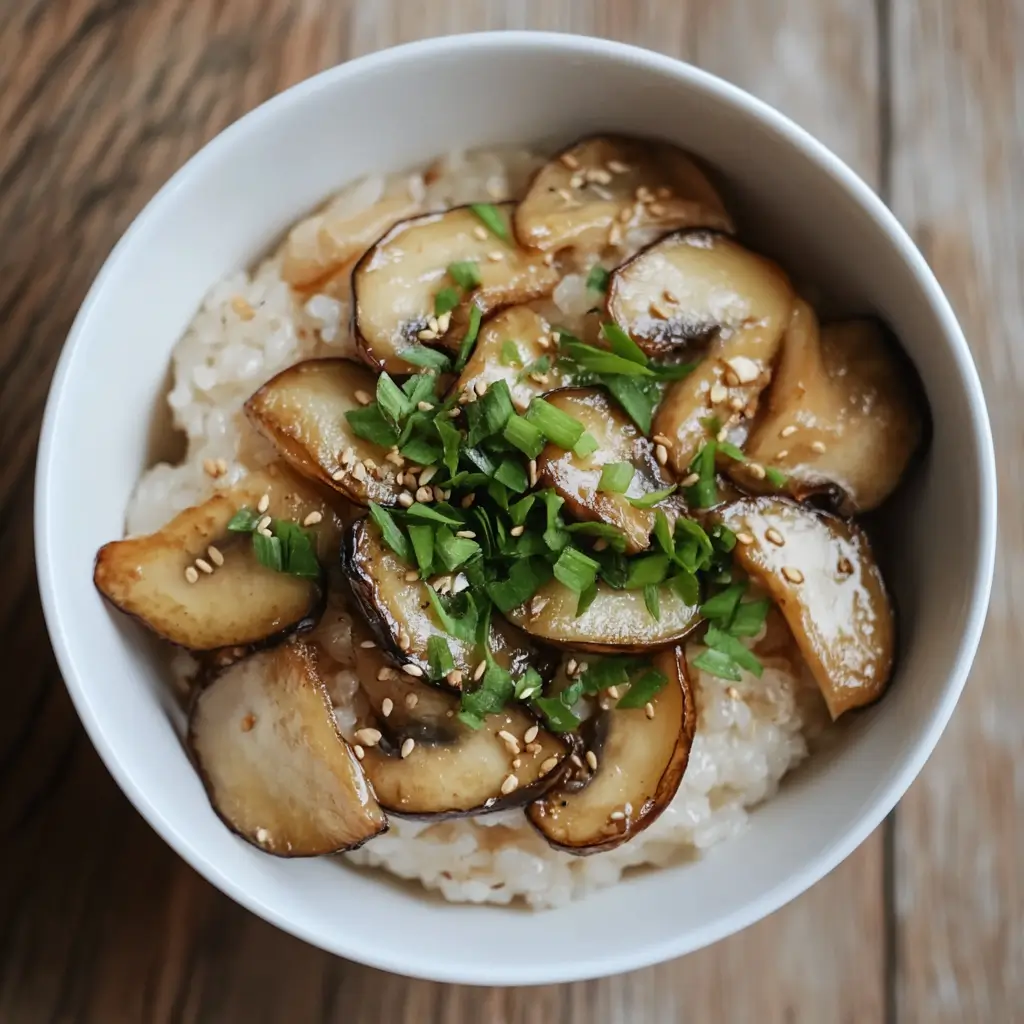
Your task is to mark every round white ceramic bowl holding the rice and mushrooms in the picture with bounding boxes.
[36,33,995,984]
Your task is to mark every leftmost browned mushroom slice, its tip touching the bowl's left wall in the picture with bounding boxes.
[93,470,331,650]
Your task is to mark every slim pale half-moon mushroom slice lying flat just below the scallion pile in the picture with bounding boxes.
[508,580,700,654]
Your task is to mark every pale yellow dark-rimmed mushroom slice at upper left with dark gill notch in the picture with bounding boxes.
[352,203,558,373]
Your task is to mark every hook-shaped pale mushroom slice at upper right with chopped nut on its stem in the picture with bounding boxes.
[626,231,793,476]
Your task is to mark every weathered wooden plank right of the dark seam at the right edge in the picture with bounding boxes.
[891,0,1024,1024]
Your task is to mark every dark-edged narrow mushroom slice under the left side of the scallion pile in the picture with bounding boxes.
[342,519,547,684]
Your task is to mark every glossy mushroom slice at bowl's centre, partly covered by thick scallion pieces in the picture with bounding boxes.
[537,388,682,554]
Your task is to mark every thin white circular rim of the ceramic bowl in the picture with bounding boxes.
[34,31,996,985]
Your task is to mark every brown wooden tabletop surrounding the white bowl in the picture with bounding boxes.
[0,0,1024,1024]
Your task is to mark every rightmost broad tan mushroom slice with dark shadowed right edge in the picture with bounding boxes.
[730,302,925,515]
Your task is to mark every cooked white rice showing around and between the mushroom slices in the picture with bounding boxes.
[127,151,823,907]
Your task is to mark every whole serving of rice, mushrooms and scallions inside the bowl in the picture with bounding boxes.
[96,136,927,907]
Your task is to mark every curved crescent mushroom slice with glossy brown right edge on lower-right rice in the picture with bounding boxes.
[526,647,696,855]
